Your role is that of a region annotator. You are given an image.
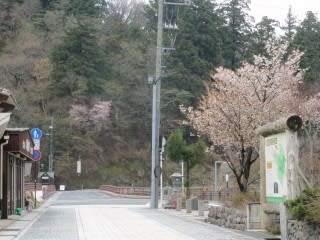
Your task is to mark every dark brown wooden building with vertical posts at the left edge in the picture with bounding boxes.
[0,128,34,219]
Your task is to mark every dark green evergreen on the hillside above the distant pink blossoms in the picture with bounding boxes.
[52,22,106,100]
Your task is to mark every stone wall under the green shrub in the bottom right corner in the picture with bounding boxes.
[287,220,320,240]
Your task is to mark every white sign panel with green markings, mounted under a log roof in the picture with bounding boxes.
[265,133,288,203]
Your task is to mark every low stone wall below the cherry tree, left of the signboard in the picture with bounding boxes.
[208,206,247,231]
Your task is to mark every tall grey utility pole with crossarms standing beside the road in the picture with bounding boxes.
[150,0,190,208]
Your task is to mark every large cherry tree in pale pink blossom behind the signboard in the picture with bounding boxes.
[181,41,303,192]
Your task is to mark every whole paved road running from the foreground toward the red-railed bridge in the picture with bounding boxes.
[12,191,266,240]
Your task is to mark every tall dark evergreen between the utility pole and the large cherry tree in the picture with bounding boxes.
[162,0,223,119]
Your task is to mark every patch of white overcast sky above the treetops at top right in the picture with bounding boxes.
[250,0,320,24]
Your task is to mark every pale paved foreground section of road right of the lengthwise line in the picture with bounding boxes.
[77,206,262,240]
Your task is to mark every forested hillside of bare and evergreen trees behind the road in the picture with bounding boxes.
[0,0,320,187]
